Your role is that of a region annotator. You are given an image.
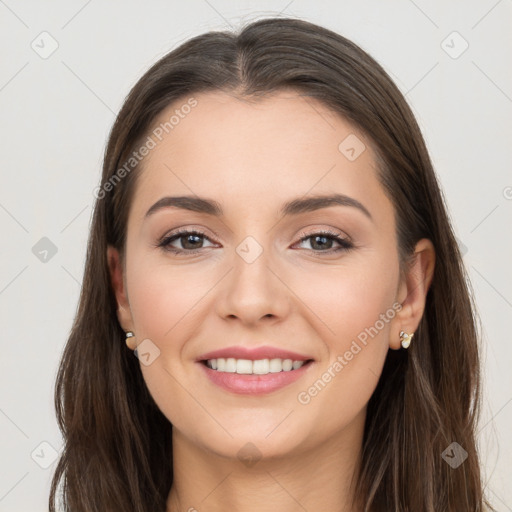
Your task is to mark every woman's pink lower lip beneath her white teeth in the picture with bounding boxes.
[198,361,313,395]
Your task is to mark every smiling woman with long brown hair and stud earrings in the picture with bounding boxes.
[50,18,494,512]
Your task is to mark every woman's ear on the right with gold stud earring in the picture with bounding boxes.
[389,238,436,350]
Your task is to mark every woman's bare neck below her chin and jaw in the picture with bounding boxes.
[167,411,365,512]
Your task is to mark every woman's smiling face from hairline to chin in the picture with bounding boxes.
[110,91,407,457]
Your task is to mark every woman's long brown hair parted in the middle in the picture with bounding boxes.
[49,18,494,512]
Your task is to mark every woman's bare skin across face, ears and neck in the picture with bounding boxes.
[108,90,435,512]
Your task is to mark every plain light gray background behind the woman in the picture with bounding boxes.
[0,0,512,512]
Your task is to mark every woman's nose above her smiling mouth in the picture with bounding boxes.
[216,242,291,325]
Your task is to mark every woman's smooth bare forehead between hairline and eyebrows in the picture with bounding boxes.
[130,90,390,222]
